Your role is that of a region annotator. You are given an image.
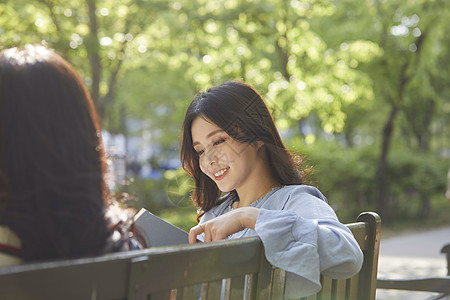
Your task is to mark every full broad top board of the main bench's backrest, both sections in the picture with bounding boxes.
[0,238,262,300]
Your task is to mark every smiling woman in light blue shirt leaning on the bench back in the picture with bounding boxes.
[181,82,363,297]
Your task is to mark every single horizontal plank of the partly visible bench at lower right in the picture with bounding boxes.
[377,276,450,294]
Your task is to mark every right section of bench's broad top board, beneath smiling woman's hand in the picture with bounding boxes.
[129,238,262,297]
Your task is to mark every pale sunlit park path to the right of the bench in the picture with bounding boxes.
[376,226,450,300]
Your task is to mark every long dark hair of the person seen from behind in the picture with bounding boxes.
[0,45,130,261]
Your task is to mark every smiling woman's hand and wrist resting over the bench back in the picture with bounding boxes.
[189,207,259,244]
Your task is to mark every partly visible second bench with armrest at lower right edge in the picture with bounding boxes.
[377,244,450,299]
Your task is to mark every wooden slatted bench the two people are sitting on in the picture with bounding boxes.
[0,213,380,300]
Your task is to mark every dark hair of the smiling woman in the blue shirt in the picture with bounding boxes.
[181,81,306,217]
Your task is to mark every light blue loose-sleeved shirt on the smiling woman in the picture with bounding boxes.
[199,185,363,298]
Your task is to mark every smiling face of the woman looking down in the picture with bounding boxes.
[191,117,261,192]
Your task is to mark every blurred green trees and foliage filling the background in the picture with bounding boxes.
[0,0,450,229]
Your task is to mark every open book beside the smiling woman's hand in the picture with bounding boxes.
[134,208,189,248]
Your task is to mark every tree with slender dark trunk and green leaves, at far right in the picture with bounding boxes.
[315,1,449,220]
